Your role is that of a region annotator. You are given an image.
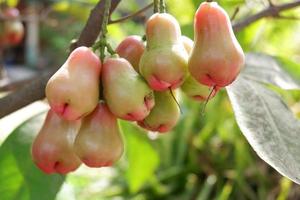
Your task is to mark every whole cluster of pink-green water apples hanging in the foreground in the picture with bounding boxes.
[32,2,244,173]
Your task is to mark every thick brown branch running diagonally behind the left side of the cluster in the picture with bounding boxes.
[0,0,121,118]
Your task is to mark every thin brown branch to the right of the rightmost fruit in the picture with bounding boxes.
[233,0,300,32]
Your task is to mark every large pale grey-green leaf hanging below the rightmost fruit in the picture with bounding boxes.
[227,75,300,184]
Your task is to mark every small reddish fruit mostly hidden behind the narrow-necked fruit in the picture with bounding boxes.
[116,35,146,72]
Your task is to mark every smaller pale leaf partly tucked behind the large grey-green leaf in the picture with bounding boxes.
[242,53,300,89]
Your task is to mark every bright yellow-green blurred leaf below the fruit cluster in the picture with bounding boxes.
[121,122,159,193]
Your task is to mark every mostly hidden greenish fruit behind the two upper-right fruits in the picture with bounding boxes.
[181,36,219,101]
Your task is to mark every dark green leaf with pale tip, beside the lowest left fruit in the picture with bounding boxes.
[0,115,64,200]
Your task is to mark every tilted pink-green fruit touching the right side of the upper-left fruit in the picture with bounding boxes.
[102,58,154,121]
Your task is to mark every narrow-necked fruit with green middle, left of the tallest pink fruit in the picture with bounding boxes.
[140,13,188,91]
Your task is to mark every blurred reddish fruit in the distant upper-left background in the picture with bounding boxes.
[0,8,24,48]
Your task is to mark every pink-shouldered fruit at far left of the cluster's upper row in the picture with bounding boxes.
[46,47,101,121]
